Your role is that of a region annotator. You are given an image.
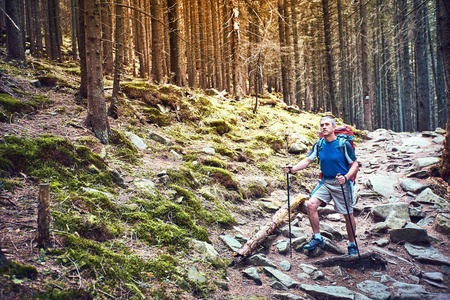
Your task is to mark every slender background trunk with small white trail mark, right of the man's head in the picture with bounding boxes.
[359,0,373,131]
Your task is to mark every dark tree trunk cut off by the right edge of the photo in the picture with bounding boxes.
[437,0,450,182]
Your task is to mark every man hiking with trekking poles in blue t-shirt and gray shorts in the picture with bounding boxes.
[284,116,358,255]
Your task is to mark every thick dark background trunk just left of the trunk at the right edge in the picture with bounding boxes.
[414,0,431,131]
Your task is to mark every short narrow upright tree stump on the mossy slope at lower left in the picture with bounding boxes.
[36,183,50,248]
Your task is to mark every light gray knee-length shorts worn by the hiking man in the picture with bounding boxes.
[310,179,353,215]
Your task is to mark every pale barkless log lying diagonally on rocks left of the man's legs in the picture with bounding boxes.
[234,195,309,258]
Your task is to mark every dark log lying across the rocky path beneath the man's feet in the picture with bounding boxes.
[314,252,387,270]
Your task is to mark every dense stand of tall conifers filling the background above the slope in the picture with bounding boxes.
[0,0,448,131]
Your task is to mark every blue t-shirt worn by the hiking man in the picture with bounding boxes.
[308,139,356,179]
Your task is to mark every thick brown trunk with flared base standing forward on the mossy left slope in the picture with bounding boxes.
[84,0,110,144]
